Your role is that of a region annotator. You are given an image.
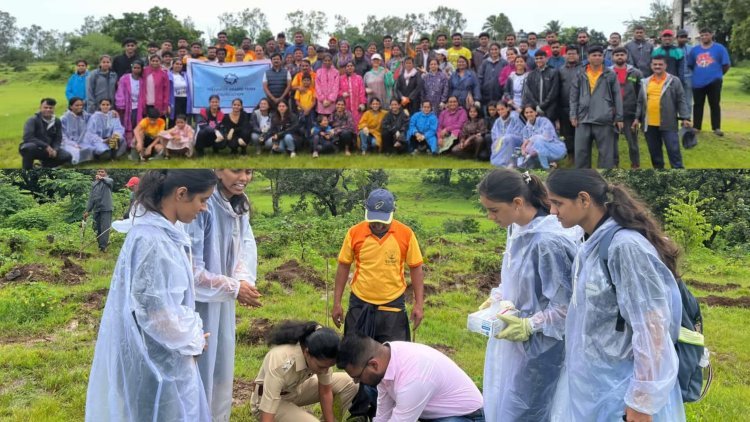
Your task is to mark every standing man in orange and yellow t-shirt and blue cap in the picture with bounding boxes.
[331,189,424,342]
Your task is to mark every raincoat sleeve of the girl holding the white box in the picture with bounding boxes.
[531,242,573,340]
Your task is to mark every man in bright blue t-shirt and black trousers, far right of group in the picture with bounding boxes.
[688,28,731,136]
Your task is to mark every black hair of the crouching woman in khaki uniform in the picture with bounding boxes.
[266,321,340,359]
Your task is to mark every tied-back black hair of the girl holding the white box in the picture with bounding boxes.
[477,169,550,213]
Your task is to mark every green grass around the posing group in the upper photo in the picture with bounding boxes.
[0,63,750,169]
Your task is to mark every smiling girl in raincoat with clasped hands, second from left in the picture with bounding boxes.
[187,169,260,421]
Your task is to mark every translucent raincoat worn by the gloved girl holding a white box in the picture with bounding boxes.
[483,215,583,422]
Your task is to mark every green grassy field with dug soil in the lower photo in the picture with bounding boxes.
[0,170,750,421]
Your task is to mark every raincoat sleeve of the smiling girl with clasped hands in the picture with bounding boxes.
[186,212,242,303]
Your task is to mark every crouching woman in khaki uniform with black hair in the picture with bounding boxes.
[251,321,358,422]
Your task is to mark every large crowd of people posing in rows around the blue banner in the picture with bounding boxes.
[20,27,729,168]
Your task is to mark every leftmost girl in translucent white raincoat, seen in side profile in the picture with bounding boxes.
[86,170,216,422]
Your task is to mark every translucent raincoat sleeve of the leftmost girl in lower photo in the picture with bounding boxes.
[131,244,205,356]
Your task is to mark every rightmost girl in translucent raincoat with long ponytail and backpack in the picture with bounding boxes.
[547,170,685,422]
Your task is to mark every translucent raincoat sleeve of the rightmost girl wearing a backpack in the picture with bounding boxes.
[609,241,681,415]
